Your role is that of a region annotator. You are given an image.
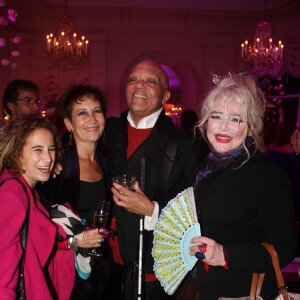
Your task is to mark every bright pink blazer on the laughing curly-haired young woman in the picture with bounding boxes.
[0,171,75,300]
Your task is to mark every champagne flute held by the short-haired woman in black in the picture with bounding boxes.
[88,200,110,257]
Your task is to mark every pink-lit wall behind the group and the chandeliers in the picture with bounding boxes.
[0,0,300,115]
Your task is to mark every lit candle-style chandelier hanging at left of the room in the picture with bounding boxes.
[46,0,89,70]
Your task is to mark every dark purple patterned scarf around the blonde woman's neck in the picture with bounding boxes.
[194,137,254,187]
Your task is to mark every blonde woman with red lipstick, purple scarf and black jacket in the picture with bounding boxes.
[190,75,297,300]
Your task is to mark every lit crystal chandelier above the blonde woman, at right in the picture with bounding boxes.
[241,21,283,78]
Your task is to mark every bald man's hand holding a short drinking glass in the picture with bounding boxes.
[111,182,155,216]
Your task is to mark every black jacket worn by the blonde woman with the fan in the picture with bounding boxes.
[195,151,297,300]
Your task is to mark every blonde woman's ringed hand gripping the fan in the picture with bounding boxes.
[190,236,225,266]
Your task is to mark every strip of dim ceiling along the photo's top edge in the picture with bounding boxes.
[44,0,299,12]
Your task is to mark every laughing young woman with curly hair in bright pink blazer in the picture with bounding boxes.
[0,115,74,300]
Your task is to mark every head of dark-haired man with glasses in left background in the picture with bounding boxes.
[2,79,42,118]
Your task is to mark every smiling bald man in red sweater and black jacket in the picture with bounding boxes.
[103,60,204,300]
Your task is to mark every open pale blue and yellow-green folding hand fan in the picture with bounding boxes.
[152,187,201,295]
